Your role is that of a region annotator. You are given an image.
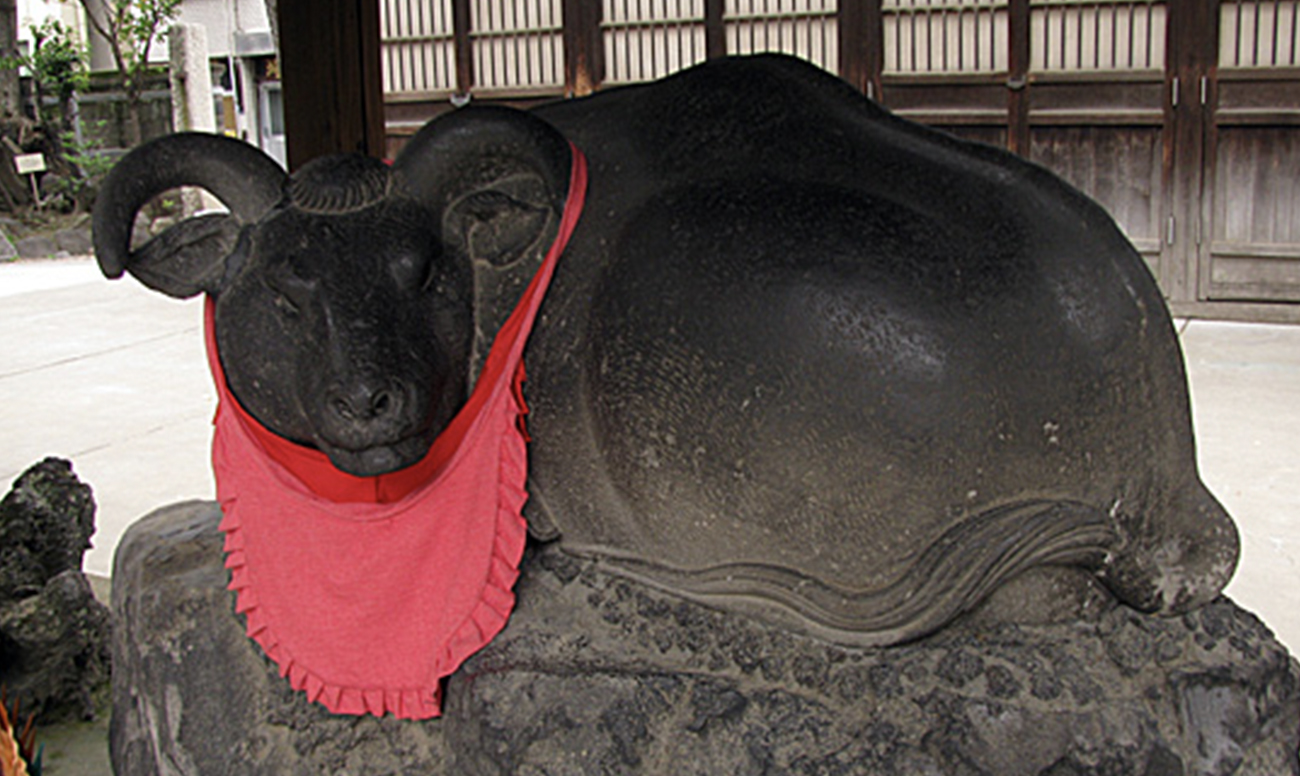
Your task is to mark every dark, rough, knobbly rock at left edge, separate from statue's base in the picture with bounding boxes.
[0,458,111,721]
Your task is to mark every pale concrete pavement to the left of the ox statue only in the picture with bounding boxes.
[0,259,216,575]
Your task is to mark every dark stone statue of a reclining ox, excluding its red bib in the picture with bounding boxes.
[95,51,1238,646]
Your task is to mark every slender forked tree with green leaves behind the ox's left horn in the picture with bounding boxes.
[81,0,181,146]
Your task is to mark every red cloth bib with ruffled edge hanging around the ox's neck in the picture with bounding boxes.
[205,148,586,719]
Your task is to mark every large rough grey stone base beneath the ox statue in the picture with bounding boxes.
[112,502,1300,776]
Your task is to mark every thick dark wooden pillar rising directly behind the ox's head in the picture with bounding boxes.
[277,0,385,170]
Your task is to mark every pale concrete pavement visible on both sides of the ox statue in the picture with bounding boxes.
[0,259,1300,653]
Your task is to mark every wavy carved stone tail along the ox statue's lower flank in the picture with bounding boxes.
[603,500,1115,646]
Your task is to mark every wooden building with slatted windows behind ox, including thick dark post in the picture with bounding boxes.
[280,0,1300,321]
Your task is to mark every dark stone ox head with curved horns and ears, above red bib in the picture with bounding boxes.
[94,108,569,476]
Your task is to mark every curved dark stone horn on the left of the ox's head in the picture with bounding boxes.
[92,133,286,278]
